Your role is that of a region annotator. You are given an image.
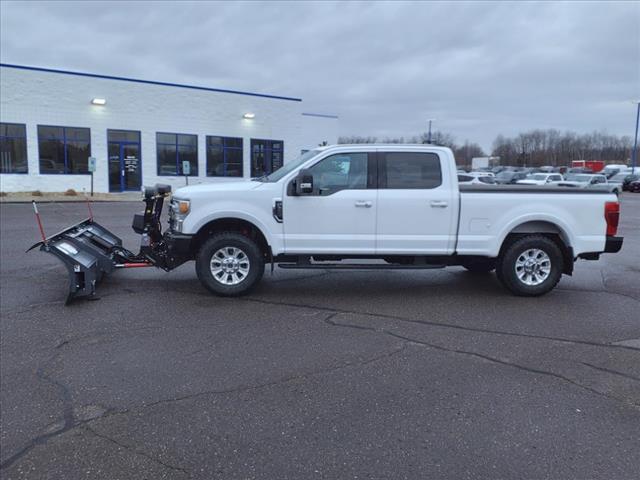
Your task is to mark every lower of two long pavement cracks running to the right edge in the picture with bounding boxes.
[324,317,640,408]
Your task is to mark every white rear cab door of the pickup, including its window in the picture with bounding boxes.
[376,151,458,255]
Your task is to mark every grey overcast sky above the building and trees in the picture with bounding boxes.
[0,1,640,148]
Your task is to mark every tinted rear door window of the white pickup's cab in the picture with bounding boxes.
[378,152,442,189]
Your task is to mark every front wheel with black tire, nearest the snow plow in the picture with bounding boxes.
[196,232,264,297]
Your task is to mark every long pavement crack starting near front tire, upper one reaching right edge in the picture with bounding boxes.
[238,297,640,351]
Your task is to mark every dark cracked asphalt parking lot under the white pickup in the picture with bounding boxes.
[0,194,640,480]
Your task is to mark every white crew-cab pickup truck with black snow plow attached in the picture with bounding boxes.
[31,145,622,299]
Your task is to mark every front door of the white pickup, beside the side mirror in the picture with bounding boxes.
[283,152,377,254]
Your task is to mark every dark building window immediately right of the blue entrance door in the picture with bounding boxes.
[156,133,198,177]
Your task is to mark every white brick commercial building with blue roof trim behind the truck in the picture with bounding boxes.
[0,64,338,193]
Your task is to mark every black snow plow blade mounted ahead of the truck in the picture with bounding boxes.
[27,219,125,305]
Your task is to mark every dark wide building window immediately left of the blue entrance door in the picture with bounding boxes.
[38,125,91,174]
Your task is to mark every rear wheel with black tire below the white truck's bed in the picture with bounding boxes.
[496,235,564,297]
